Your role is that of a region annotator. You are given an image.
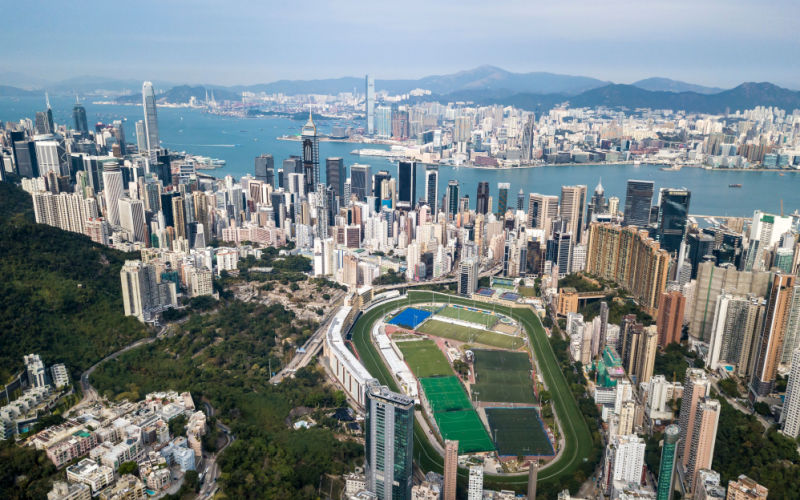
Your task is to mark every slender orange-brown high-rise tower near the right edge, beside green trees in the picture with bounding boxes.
[751,274,797,396]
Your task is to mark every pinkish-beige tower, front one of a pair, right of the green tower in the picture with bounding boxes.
[684,394,720,493]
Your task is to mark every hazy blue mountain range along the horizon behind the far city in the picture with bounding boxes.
[0,66,800,113]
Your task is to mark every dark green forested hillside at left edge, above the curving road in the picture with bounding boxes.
[0,182,147,383]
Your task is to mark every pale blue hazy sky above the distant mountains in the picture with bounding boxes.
[0,0,800,89]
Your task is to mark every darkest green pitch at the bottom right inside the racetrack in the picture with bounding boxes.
[486,408,554,457]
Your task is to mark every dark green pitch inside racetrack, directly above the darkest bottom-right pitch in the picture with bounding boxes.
[472,349,536,403]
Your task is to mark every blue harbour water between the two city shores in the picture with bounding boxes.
[0,97,800,216]
